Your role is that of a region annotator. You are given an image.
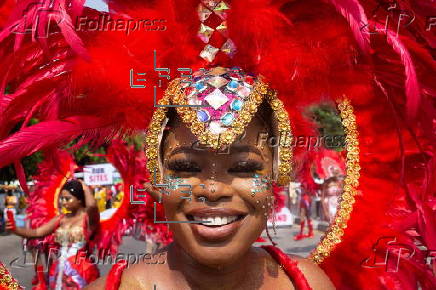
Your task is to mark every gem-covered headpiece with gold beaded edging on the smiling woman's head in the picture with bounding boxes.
[146,67,292,185]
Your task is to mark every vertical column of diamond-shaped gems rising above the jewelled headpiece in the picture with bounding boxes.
[197,0,236,62]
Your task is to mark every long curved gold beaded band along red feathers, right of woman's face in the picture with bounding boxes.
[310,96,360,264]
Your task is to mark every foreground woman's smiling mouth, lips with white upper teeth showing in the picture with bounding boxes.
[186,208,247,242]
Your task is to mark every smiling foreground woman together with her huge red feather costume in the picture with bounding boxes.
[0,0,436,289]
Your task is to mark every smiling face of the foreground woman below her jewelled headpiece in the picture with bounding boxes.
[162,117,274,267]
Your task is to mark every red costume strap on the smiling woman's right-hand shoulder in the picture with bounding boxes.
[261,246,312,290]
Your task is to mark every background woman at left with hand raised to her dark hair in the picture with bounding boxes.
[7,179,100,289]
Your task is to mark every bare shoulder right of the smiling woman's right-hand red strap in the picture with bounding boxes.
[289,255,336,290]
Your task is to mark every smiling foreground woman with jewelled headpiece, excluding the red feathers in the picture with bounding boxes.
[89,67,333,289]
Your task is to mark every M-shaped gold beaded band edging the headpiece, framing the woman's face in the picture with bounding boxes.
[145,79,292,185]
